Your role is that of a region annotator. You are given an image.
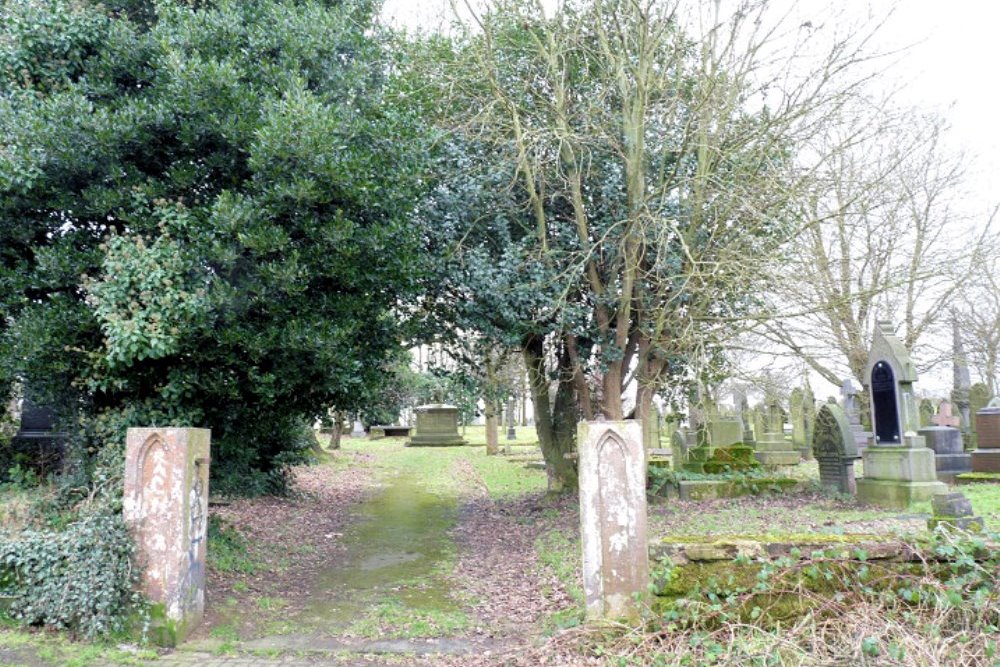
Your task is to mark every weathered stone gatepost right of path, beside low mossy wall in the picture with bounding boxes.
[577,420,649,622]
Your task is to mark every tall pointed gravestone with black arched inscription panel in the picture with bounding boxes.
[858,322,947,508]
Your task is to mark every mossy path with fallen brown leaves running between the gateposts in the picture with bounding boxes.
[151,443,573,667]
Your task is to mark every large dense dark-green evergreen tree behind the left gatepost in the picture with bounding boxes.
[0,0,422,482]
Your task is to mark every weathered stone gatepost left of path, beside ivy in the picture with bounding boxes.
[124,428,211,646]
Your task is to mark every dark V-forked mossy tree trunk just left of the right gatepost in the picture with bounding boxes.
[523,335,577,494]
